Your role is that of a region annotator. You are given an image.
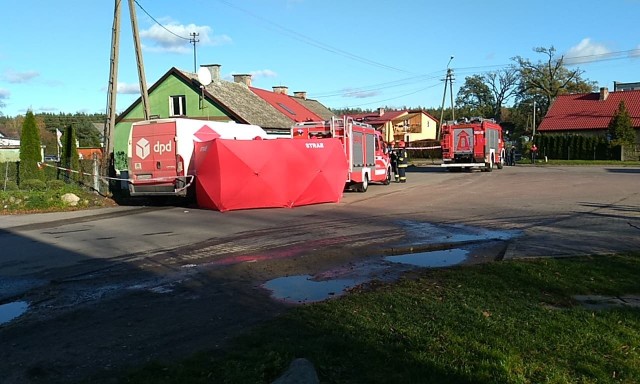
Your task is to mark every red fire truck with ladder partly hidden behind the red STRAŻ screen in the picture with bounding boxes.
[291,116,391,192]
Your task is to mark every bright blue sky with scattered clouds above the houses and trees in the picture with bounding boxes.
[0,0,640,116]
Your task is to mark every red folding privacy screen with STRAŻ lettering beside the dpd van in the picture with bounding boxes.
[195,139,348,211]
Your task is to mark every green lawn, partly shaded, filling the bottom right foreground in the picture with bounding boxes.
[114,254,640,383]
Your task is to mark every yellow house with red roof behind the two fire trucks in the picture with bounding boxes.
[349,108,437,143]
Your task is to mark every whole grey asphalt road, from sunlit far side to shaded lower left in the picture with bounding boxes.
[0,165,640,383]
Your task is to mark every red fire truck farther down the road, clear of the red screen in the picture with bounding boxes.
[440,118,505,172]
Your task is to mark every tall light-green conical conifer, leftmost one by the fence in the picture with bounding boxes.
[20,110,44,182]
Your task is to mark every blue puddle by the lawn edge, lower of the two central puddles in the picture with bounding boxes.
[263,275,367,303]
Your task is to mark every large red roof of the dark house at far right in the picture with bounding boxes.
[538,88,640,144]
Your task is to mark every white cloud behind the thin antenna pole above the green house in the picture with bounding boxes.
[140,21,231,54]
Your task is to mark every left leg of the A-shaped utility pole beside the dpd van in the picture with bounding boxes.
[102,0,120,177]
